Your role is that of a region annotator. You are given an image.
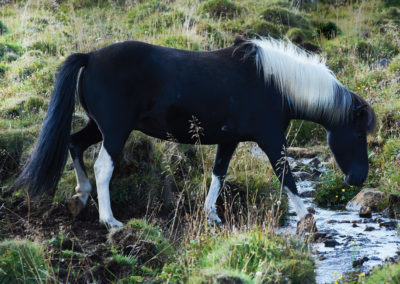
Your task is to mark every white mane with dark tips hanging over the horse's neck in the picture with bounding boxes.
[249,38,352,122]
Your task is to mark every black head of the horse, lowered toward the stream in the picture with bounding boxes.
[327,94,376,185]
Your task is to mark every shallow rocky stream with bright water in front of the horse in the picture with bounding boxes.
[251,147,400,283]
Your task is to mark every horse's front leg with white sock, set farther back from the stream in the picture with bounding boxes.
[204,143,237,223]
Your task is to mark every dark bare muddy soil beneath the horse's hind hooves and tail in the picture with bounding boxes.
[0,192,167,283]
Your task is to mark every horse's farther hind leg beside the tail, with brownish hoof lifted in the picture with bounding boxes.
[69,120,102,216]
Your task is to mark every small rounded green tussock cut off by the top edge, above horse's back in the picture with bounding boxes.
[202,0,242,18]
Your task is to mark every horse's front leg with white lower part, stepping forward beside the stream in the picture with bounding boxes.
[258,139,308,219]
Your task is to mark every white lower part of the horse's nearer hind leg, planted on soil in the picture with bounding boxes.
[94,145,123,227]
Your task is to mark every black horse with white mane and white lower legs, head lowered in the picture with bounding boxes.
[14,38,376,227]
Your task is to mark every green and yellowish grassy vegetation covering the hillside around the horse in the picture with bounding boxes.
[0,0,400,283]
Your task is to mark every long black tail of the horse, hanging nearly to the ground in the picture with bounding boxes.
[13,53,89,196]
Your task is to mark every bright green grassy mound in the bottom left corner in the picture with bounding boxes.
[0,240,51,283]
